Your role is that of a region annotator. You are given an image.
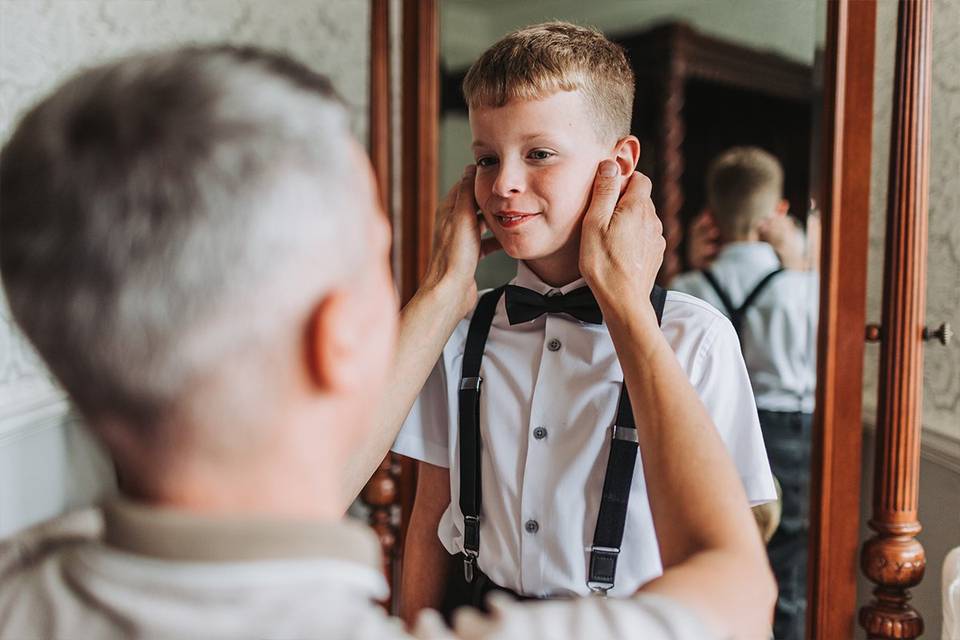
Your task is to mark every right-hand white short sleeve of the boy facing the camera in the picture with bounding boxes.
[692,316,777,506]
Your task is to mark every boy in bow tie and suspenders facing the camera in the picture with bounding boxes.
[394,23,775,619]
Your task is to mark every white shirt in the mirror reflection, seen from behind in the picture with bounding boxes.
[670,242,820,413]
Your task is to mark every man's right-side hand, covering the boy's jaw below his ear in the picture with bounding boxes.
[580,160,666,309]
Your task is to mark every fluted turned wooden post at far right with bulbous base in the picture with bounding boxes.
[860,0,931,639]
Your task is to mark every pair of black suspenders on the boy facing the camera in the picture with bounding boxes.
[459,286,667,594]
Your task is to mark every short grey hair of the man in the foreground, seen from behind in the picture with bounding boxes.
[0,46,366,436]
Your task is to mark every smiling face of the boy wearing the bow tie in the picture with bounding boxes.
[470,91,612,261]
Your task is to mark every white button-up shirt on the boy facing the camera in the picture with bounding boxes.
[394,263,776,596]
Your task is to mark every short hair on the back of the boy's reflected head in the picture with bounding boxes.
[707,147,783,238]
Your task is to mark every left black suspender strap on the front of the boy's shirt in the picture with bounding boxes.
[459,287,503,583]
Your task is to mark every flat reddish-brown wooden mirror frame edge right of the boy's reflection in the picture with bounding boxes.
[807,0,876,640]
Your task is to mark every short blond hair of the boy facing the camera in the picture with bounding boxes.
[463,22,634,142]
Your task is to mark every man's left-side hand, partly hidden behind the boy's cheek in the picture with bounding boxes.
[422,164,500,317]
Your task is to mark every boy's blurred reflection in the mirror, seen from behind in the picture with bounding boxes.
[670,147,819,640]
